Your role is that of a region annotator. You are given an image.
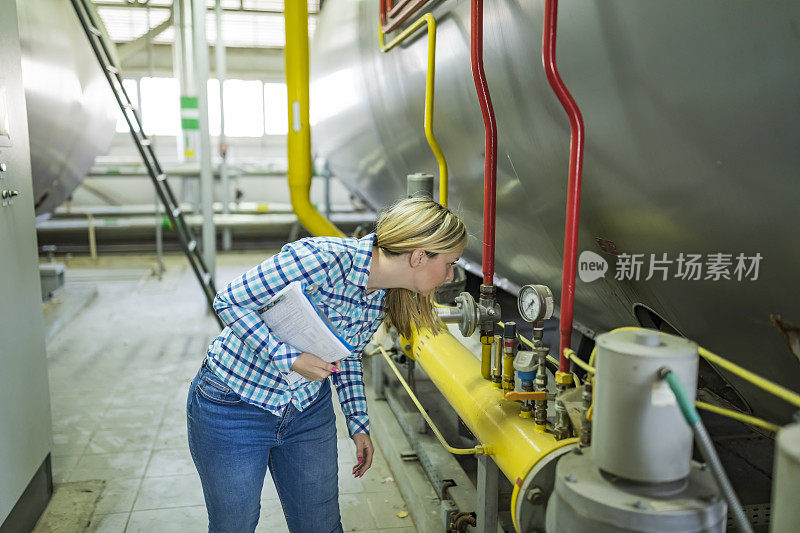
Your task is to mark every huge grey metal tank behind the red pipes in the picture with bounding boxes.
[311,0,800,422]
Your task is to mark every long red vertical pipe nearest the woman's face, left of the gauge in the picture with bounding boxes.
[470,0,497,285]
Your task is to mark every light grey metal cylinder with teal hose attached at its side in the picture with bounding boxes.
[591,329,698,483]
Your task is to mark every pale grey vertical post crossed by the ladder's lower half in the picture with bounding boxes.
[192,0,217,278]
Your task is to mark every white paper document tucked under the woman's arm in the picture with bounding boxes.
[261,281,354,384]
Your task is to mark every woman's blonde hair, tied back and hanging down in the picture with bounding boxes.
[375,198,468,337]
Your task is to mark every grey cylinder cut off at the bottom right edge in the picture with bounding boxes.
[770,424,800,533]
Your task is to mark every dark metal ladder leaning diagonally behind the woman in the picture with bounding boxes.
[71,0,224,327]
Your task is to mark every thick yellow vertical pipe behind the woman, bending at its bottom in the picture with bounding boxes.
[283,0,344,237]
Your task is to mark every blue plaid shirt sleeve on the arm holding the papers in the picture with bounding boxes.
[214,241,332,372]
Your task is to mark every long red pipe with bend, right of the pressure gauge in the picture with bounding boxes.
[542,0,584,372]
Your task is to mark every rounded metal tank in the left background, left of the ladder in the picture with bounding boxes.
[17,0,117,216]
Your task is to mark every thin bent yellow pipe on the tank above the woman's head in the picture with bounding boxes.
[378,13,447,207]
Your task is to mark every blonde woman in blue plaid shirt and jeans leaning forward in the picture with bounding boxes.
[186,198,467,533]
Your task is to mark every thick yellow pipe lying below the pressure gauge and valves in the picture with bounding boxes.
[403,330,577,485]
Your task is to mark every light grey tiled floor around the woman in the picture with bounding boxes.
[37,254,417,532]
